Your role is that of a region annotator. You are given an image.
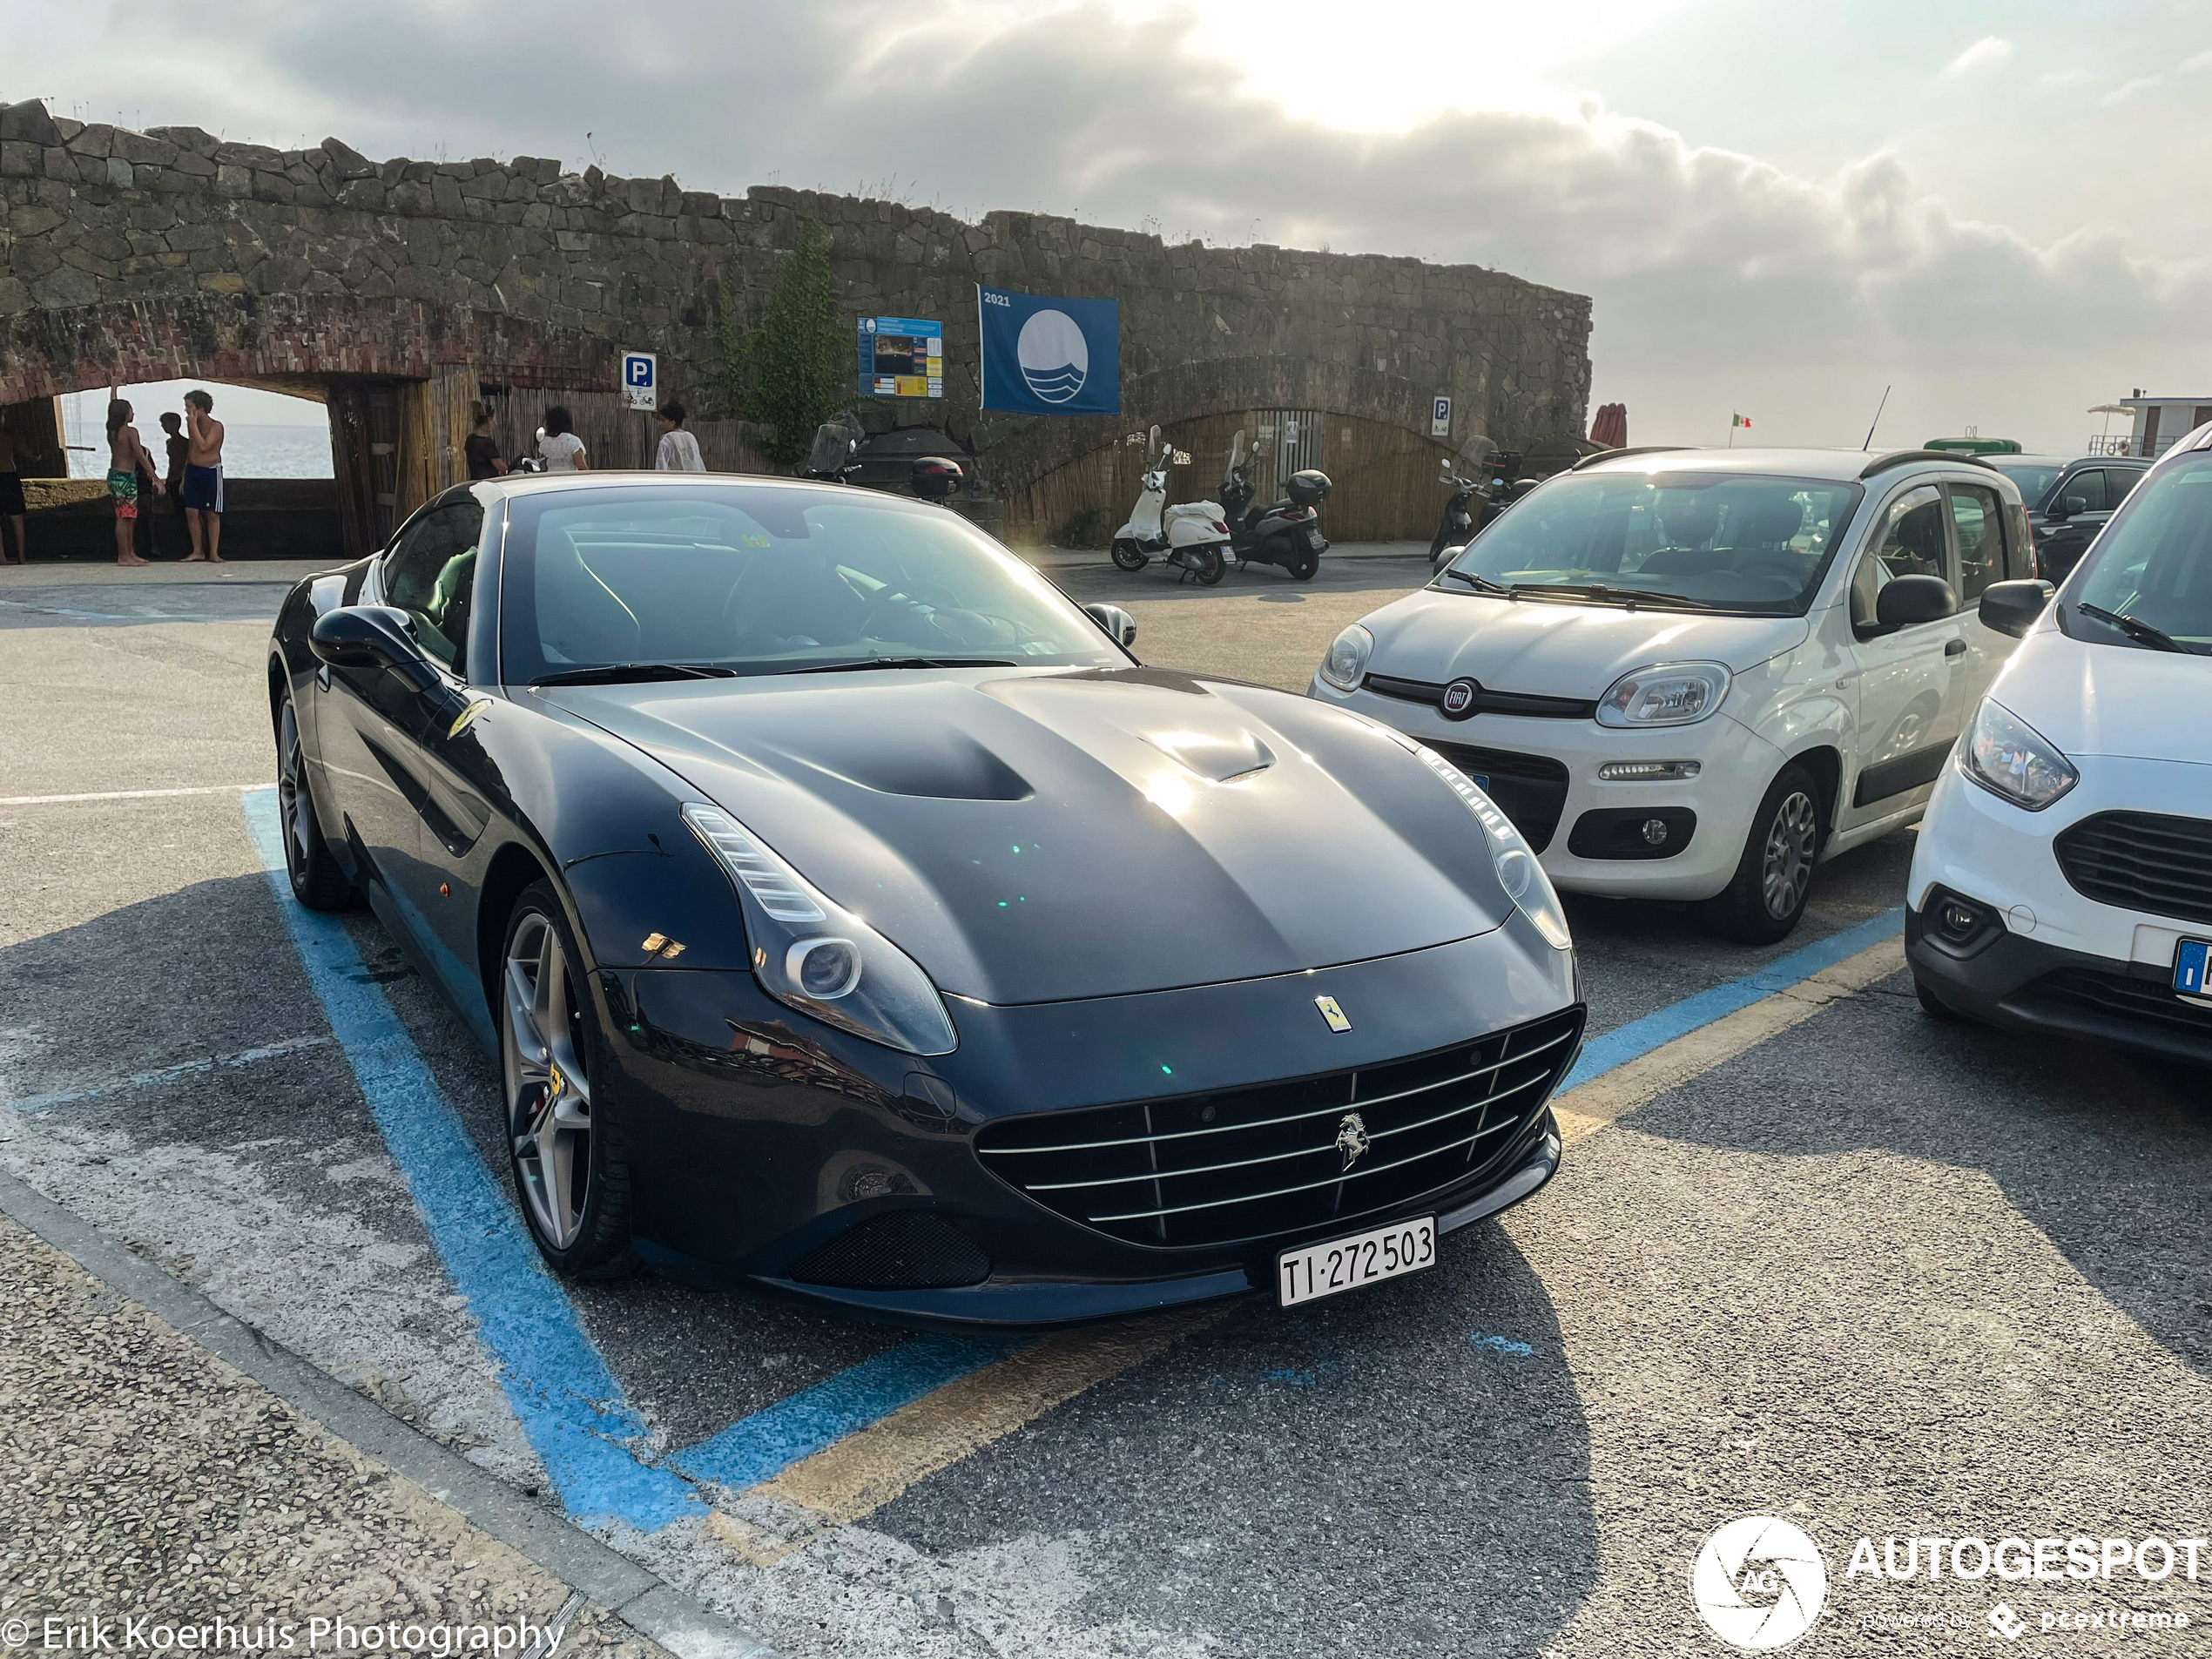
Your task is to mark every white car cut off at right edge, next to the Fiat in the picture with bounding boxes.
[1905,425,2212,1064]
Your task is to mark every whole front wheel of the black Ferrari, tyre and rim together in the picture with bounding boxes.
[498,880,637,1278]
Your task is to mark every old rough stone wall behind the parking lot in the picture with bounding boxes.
[0,102,1590,535]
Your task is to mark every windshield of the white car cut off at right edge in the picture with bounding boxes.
[2060,455,2212,655]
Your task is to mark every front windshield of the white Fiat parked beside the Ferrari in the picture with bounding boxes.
[1440,471,1865,615]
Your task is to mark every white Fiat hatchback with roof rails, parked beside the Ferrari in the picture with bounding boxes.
[1310,449,2033,945]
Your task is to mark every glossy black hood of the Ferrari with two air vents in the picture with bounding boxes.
[550,668,1511,1004]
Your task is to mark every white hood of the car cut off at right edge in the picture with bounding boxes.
[1988,617,2212,765]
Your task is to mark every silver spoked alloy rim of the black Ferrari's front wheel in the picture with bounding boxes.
[500,911,590,1250]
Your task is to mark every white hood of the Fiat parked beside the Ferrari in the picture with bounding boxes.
[1363,589,1810,701]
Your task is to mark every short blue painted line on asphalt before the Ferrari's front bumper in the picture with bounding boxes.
[668,1336,1033,1491]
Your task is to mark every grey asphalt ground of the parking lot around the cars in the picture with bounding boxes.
[0,549,2212,1659]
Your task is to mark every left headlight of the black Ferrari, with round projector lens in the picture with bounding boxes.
[684,803,960,1055]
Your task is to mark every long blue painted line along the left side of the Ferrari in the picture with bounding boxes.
[241,790,705,1531]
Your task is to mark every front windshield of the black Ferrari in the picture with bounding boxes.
[500,484,1126,684]
